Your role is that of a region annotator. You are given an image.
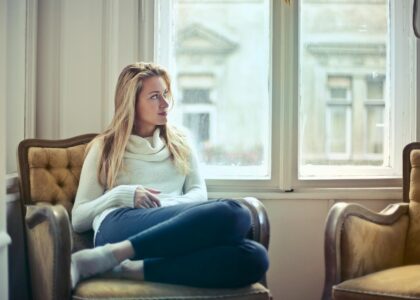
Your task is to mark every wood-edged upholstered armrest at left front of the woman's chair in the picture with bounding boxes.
[25,204,71,300]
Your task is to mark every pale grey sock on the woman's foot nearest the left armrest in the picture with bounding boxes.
[71,244,119,288]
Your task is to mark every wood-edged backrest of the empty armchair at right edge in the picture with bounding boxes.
[403,143,420,264]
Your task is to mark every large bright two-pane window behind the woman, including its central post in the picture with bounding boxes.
[154,0,416,191]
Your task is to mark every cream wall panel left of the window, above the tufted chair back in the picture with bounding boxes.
[36,0,138,138]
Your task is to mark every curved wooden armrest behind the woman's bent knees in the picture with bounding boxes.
[237,197,270,250]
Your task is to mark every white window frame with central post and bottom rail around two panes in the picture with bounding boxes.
[140,0,420,199]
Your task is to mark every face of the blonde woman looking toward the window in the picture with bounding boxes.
[134,76,170,137]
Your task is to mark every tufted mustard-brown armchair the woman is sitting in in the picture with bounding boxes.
[18,134,271,300]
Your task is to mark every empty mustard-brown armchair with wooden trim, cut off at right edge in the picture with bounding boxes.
[323,142,420,300]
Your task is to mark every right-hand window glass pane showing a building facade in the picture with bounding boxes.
[299,0,391,178]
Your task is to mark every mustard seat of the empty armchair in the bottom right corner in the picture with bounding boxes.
[333,265,420,300]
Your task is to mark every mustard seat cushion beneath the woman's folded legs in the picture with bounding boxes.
[73,278,270,300]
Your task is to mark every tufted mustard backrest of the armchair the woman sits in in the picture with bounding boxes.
[18,134,96,251]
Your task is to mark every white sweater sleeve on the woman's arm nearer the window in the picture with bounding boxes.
[161,139,207,206]
